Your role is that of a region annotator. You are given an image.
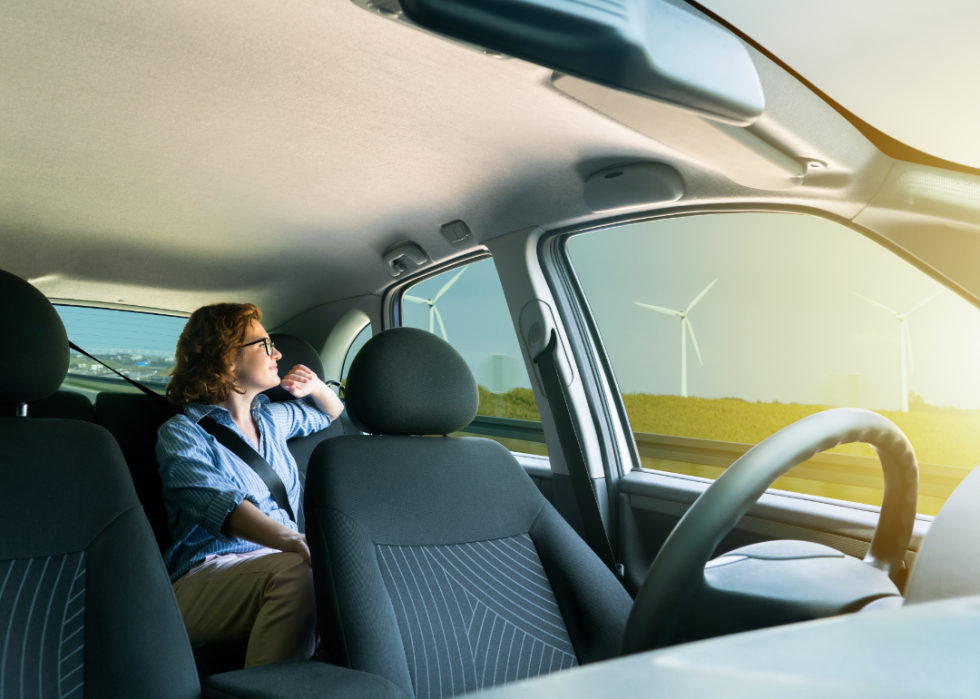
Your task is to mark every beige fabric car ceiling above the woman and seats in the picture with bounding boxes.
[0,0,890,327]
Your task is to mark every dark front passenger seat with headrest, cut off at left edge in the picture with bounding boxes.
[0,272,200,699]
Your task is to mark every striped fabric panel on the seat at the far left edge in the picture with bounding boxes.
[0,552,85,699]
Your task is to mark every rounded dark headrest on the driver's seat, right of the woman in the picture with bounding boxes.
[345,328,480,435]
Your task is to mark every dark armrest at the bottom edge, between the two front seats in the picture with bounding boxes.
[203,660,410,699]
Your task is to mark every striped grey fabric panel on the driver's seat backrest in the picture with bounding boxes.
[377,534,578,699]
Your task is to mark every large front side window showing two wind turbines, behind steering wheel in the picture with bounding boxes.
[568,213,980,514]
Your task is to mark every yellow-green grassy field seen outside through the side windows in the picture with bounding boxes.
[472,387,980,514]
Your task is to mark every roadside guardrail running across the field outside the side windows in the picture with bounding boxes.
[462,415,972,504]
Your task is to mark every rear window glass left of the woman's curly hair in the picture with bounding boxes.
[55,305,187,392]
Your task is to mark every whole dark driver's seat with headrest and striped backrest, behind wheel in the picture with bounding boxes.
[305,328,632,697]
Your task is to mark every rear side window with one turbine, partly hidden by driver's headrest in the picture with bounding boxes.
[402,260,547,455]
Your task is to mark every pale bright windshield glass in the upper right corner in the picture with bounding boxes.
[701,0,980,167]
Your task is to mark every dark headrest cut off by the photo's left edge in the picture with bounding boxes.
[0,270,69,403]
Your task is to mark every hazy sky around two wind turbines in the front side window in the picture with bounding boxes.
[569,214,980,410]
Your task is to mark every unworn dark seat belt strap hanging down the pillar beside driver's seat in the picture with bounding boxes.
[534,330,625,582]
